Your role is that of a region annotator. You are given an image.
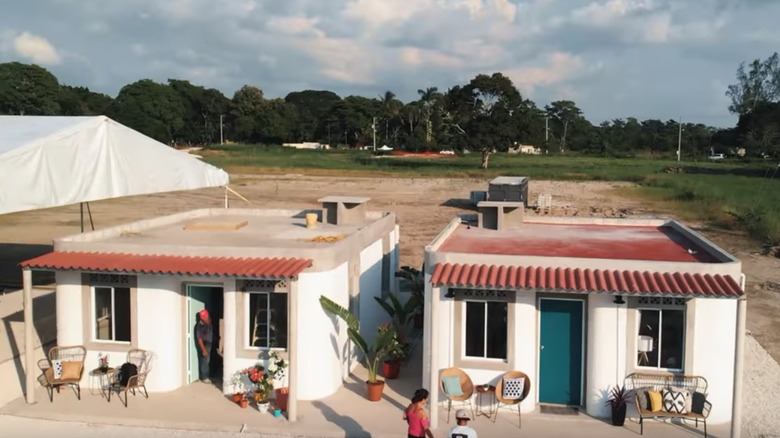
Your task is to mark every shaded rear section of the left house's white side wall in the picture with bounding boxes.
[360,239,384,344]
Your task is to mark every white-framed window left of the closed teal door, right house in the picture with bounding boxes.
[456,290,509,360]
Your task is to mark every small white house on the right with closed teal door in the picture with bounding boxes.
[423,202,745,424]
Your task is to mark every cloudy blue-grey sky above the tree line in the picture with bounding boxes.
[0,0,780,127]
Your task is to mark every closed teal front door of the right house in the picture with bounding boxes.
[539,298,584,406]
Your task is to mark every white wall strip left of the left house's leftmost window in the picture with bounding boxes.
[54,271,83,346]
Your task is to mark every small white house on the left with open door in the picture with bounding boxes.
[22,196,399,420]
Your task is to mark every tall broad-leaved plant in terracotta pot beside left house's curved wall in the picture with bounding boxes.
[320,295,396,401]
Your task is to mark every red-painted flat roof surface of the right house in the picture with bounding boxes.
[436,222,722,263]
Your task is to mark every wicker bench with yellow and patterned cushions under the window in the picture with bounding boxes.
[626,373,712,438]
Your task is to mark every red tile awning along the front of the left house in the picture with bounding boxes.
[20,251,312,278]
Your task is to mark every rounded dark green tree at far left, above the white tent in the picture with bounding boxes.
[0,62,60,115]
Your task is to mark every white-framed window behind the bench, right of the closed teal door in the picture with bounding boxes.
[636,297,685,370]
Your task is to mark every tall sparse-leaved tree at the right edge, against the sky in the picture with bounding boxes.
[726,52,780,115]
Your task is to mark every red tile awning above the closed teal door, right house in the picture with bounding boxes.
[431,263,744,297]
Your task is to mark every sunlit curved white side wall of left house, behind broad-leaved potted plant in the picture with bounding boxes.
[296,264,350,400]
